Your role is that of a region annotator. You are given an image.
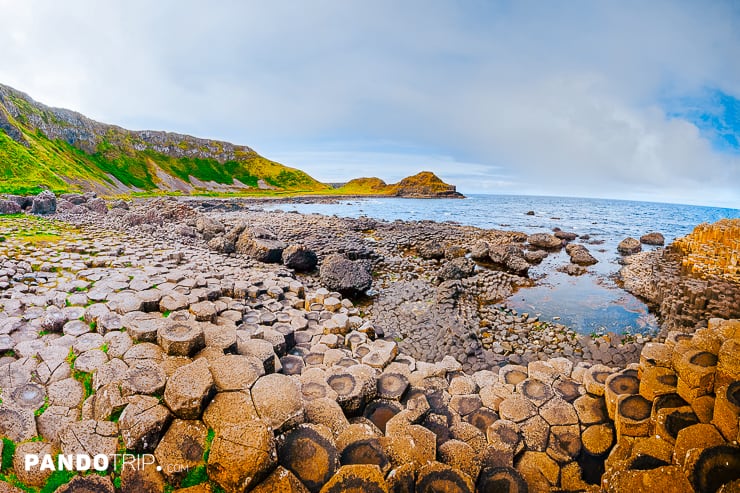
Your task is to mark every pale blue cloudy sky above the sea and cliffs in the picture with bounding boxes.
[0,0,740,208]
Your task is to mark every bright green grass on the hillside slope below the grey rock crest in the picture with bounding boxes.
[0,86,328,195]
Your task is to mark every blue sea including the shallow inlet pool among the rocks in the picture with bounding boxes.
[266,195,740,333]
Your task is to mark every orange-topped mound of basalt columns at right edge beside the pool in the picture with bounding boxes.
[620,219,740,332]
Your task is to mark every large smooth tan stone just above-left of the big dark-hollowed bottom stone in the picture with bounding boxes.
[252,373,304,432]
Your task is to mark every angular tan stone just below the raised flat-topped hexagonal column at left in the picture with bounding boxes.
[164,358,214,419]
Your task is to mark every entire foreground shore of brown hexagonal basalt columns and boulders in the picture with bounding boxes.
[0,191,740,493]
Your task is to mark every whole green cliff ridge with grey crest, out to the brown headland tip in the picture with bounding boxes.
[0,84,462,197]
